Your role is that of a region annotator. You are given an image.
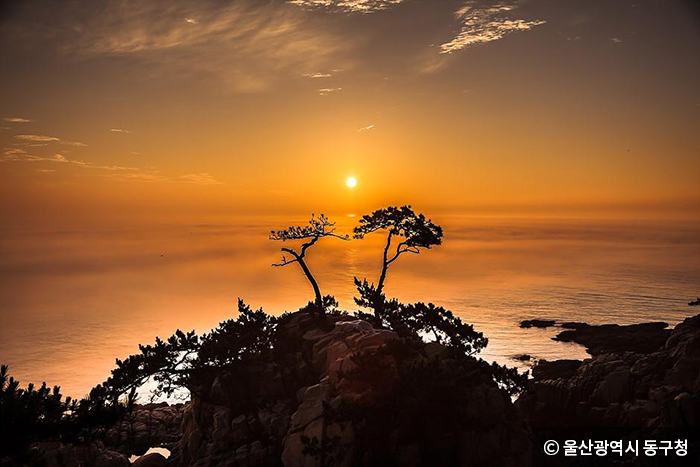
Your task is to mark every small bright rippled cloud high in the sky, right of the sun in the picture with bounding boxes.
[440,1,546,54]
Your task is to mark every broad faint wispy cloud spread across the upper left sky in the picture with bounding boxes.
[14,0,352,93]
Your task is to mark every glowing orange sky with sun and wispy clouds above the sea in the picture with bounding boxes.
[0,0,700,229]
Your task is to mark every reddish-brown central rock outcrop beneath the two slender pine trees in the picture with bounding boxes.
[173,313,531,467]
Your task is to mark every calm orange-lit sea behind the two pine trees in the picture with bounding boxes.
[0,216,700,396]
